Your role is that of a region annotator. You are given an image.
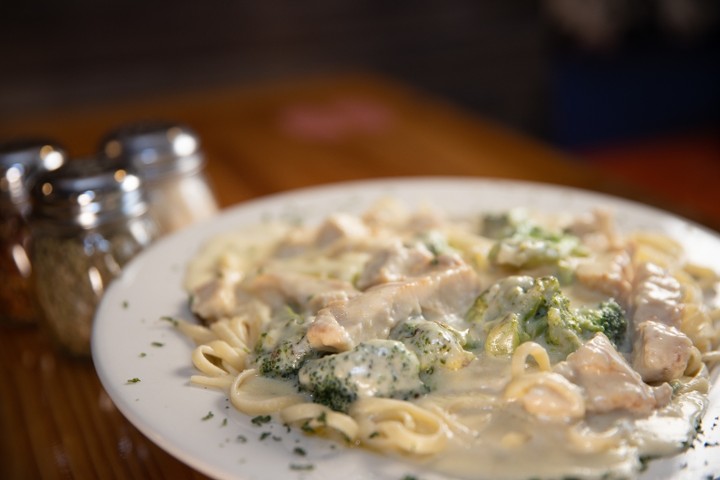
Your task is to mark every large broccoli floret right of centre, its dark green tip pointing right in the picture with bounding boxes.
[466,276,627,356]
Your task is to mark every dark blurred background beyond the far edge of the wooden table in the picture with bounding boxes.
[0,0,720,217]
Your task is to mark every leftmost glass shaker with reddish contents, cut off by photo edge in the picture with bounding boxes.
[0,139,66,326]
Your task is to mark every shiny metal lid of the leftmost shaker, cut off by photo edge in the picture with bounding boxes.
[0,139,67,204]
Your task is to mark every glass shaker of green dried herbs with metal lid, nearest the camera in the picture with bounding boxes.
[30,159,158,357]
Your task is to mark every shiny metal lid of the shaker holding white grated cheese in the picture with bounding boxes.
[100,121,205,181]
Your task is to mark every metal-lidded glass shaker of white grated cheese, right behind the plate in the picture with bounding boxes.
[100,122,218,234]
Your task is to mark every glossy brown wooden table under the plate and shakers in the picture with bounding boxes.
[0,75,708,479]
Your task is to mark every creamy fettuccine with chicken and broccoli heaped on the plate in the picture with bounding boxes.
[179,199,720,479]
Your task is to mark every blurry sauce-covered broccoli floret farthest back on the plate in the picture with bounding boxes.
[482,210,586,268]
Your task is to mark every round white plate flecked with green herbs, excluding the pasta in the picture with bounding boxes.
[92,178,720,480]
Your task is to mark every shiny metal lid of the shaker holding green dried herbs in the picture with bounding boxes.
[31,158,147,228]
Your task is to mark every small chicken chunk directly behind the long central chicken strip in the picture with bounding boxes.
[356,240,434,290]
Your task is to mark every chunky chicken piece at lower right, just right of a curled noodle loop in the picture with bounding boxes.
[555,333,672,414]
